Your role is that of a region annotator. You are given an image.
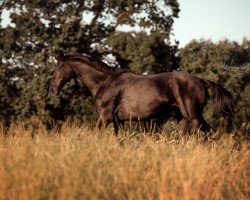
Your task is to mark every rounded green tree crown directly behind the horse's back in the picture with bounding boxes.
[108,32,179,73]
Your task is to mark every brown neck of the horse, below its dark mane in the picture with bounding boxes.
[72,63,109,96]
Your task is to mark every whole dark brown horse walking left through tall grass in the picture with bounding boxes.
[50,52,234,134]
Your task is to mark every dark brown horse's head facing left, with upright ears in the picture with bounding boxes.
[49,51,74,95]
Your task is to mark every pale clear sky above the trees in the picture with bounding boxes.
[2,0,250,47]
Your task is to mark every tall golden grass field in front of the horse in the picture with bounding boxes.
[0,124,250,200]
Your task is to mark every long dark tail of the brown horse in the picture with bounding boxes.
[205,80,235,129]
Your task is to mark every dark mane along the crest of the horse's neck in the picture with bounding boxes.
[56,52,126,76]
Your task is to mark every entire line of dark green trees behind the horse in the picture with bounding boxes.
[0,0,250,127]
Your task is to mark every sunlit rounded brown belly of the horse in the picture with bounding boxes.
[118,78,169,120]
